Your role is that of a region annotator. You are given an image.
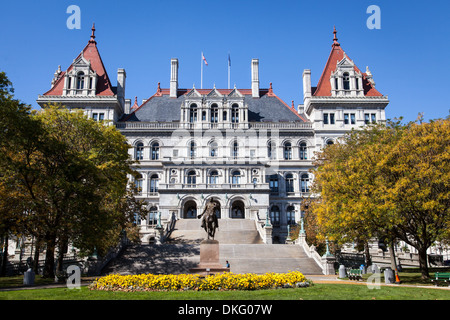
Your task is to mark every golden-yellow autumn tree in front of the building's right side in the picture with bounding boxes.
[312,120,450,278]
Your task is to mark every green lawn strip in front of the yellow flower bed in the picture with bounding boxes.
[0,283,450,300]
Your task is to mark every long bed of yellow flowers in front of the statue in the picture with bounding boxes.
[90,271,306,291]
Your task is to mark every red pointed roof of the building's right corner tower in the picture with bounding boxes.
[313,29,383,97]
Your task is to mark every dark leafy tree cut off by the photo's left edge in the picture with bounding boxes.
[0,72,41,275]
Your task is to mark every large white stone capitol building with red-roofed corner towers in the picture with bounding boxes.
[37,28,389,243]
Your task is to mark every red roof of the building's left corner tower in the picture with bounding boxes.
[44,26,114,96]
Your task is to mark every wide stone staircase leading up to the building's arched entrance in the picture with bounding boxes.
[103,219,322,275]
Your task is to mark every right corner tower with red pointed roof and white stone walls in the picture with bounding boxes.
[303,28,389,148]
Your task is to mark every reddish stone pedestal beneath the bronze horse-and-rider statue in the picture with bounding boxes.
[189,239,230,275]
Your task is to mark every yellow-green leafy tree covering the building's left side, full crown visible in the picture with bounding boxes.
[30,105,138,277]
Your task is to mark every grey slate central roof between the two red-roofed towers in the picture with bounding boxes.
[121,87,307,122]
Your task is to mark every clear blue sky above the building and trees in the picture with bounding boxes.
[0,0,450,121]
